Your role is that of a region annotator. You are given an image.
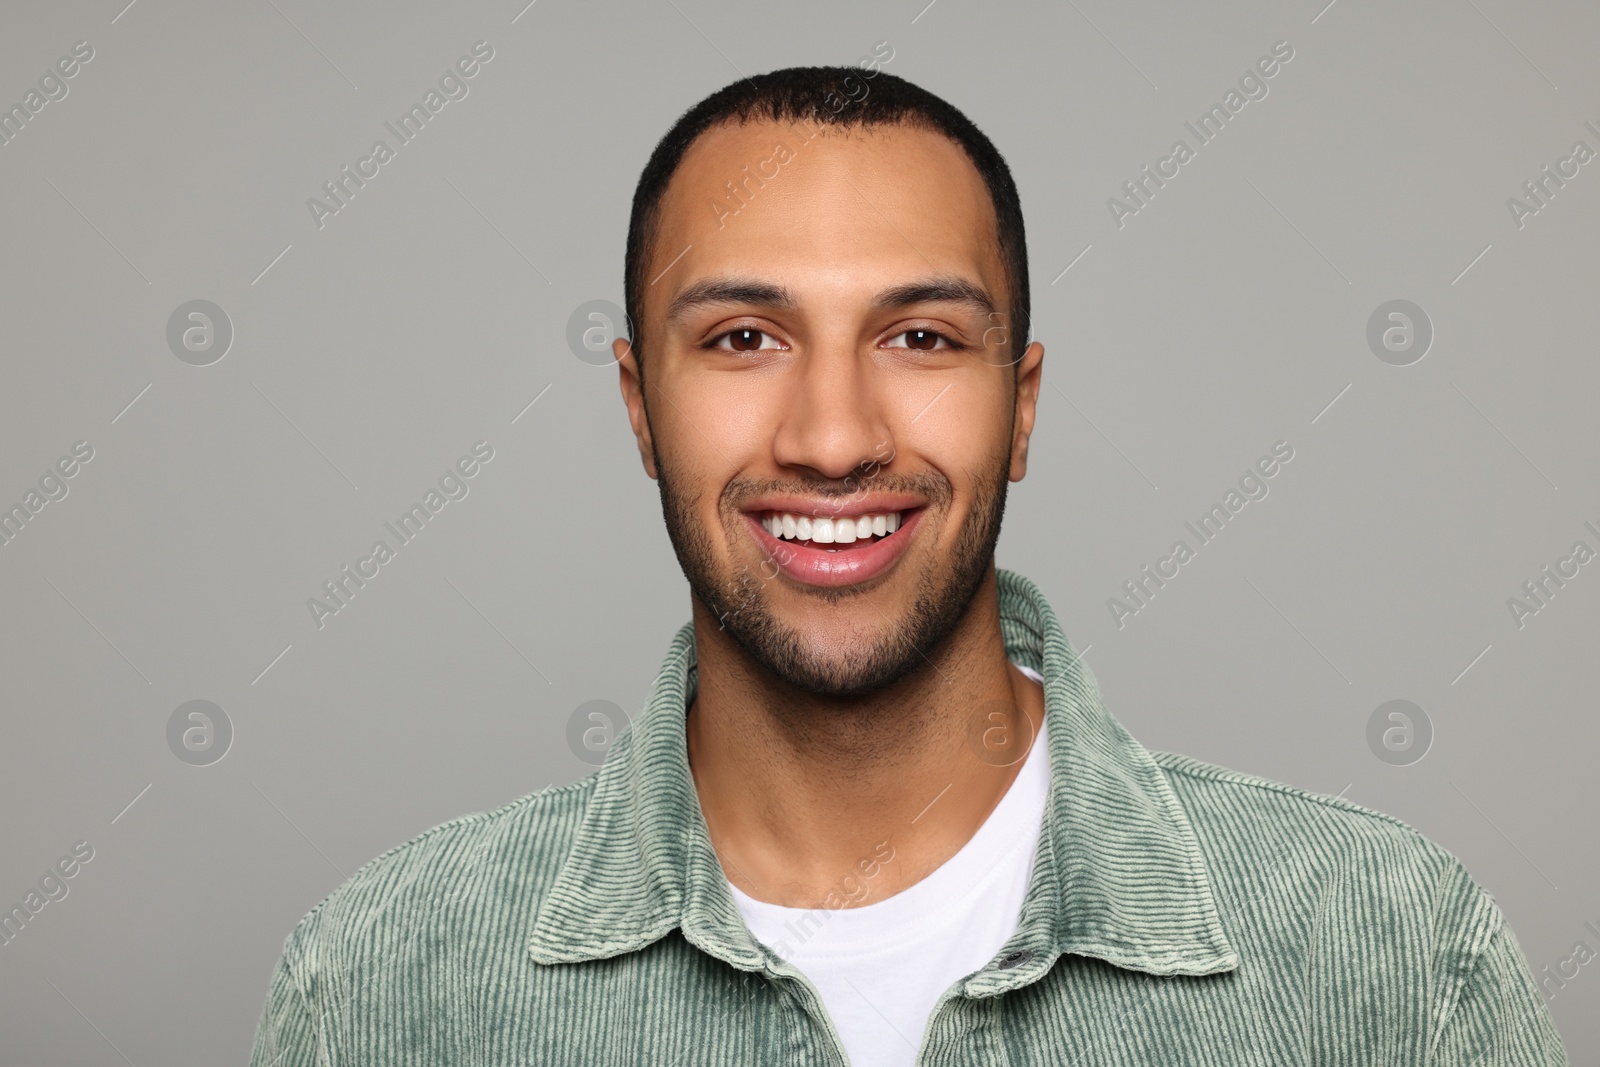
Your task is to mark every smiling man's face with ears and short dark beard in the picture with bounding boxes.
[616,122,1043,697]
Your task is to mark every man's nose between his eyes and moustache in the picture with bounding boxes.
[773,342,894,478]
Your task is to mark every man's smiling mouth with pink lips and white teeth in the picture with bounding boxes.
[746,507,925,587]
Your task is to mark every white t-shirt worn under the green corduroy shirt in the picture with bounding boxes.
[728,664,1050,1067]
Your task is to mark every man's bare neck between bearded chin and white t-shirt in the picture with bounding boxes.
[686,566,1045,907]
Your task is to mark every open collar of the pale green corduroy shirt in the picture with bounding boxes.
[528,569,1238,995]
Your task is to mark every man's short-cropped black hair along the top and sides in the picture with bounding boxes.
[624,67,1029,370]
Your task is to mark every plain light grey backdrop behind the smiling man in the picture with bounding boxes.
[0,0,1600,1067]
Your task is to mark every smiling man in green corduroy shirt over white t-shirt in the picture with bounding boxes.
[254,69,1566,1067]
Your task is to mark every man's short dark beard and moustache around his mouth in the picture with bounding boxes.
[656,441,1011,699]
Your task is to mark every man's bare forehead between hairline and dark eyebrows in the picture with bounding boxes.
[645,120,1006,314]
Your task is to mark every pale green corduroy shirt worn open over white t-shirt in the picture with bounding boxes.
[251,569,1566,1067]
